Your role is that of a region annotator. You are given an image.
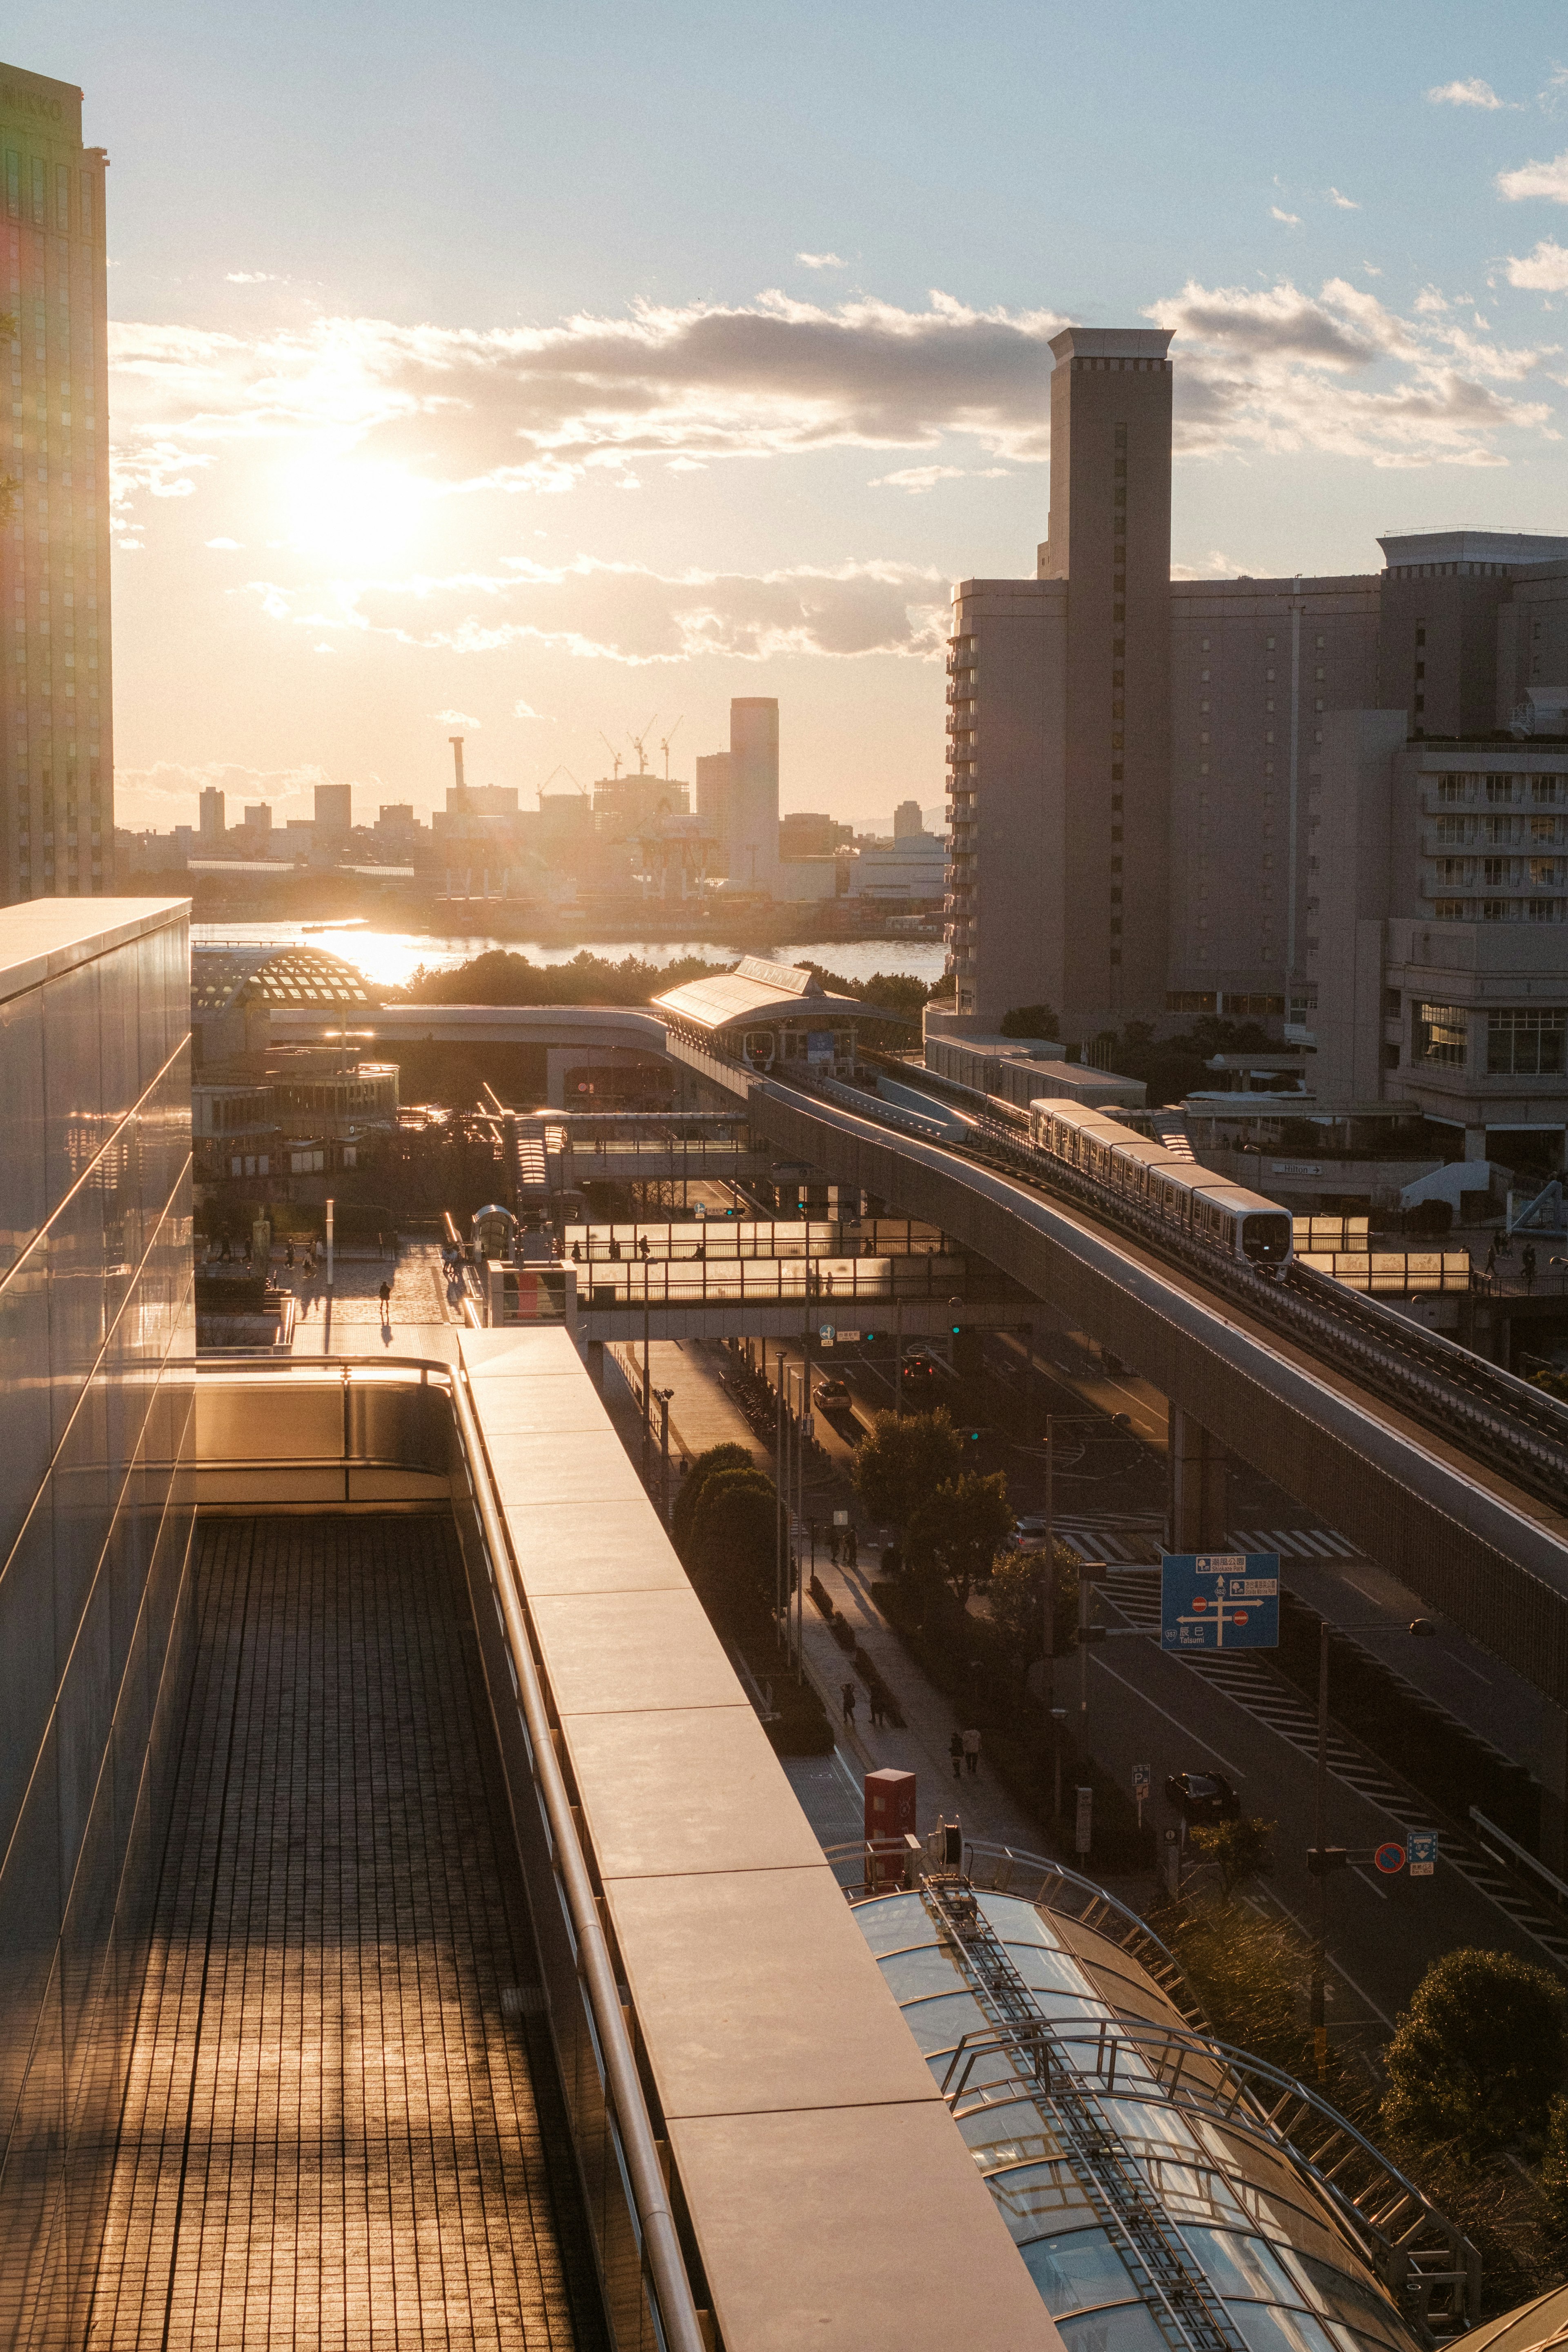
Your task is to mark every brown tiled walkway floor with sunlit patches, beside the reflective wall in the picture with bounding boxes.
[87,1519,604,2352]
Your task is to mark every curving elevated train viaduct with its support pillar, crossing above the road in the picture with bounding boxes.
[273,1007,1568,1731]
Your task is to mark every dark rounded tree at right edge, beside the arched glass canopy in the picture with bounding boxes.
[1382,1950,1568,2152]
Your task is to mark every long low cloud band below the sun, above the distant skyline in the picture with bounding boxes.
[252,555,950,668]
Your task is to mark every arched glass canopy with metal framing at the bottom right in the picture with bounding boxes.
[853,1856,1476,2352]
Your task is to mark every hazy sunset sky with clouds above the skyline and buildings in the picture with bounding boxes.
[15,0,1568,828]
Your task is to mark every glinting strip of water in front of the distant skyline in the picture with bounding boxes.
[190,922,947,988]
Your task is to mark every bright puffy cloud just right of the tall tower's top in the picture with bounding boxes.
[1147,278,1556,466]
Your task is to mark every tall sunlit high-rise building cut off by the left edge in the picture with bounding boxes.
[0,66,115,903]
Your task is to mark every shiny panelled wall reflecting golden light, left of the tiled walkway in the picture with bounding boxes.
[0,898,195,2345]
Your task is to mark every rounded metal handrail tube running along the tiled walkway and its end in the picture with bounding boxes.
[186,1350,705,2352]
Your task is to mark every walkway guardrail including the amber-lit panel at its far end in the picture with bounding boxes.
[181,1352,710,2352]
